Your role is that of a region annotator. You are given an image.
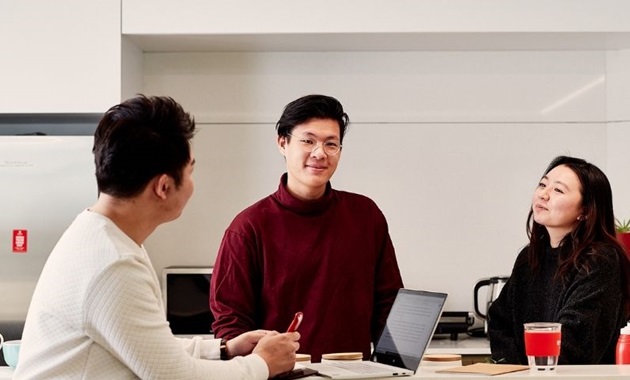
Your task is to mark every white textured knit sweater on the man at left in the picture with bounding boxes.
[14,211,268,380]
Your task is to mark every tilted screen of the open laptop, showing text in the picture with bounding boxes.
[372,289,447,371]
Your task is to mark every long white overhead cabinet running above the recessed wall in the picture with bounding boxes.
[122,0,630,52]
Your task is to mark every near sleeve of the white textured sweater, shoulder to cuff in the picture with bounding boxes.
[84,258,268,379]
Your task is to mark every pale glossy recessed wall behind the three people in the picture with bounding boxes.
[144,51,629,318]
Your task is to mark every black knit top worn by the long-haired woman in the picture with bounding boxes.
[488,248,626,364]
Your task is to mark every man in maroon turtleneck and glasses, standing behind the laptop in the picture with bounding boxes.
[210,95,403,362]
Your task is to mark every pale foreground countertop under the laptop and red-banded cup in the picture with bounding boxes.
[0,365,630,380]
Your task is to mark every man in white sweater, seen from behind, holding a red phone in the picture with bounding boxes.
[14,96,299,380]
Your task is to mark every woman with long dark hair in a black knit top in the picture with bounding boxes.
[488,156,630,364]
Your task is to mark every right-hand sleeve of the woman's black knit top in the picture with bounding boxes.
[556,251,623,364]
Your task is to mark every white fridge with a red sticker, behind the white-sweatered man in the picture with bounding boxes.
[0,136,98,320]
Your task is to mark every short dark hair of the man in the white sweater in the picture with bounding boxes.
[92,95,195,198]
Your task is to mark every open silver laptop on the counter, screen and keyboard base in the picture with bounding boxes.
[306,289,447,379]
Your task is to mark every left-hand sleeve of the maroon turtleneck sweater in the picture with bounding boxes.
[210,229,259,339]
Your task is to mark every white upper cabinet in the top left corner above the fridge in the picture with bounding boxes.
[0,0,121,114]
